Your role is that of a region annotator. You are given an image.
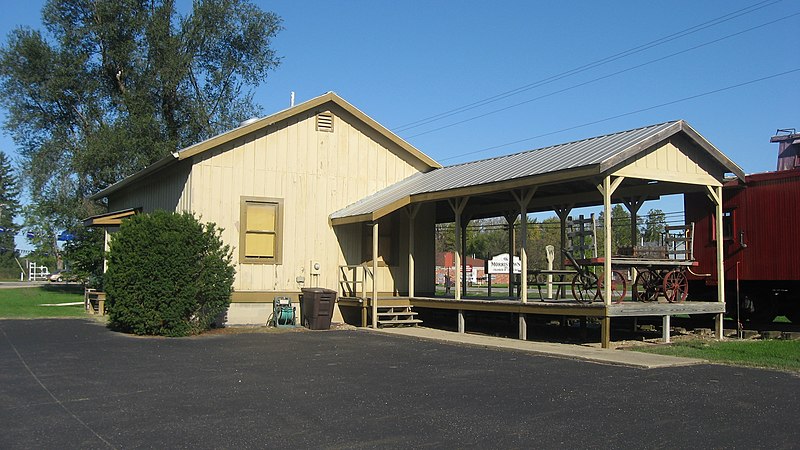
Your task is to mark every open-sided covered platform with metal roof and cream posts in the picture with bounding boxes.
[330,120,744,347]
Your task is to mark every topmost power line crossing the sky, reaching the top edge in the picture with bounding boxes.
[392,0,782,132]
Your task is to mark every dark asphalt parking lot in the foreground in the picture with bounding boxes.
[0,319,800,449]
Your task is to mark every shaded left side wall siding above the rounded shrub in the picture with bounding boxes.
[108,161,192,213]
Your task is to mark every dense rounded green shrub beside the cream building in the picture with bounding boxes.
[104,211,235,336]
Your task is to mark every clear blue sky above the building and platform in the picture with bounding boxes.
[0,0,800,246]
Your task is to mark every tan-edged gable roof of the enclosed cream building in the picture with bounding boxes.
[90,92,442,200]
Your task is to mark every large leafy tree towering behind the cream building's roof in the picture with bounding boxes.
[0,0,281,229]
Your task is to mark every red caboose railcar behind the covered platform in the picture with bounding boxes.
[684,130,800,323]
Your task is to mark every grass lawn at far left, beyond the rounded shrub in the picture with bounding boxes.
[0,285,86,319]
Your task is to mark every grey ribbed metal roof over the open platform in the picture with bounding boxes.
[330,120,744,224]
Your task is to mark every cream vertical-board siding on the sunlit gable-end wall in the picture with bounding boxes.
[191,104,420,291]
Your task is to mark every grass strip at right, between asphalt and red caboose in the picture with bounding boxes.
[632,339,800,371]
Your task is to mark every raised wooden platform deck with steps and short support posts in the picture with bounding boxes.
[339,297,725,348]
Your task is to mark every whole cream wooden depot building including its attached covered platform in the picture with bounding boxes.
[86,93,744,346]
